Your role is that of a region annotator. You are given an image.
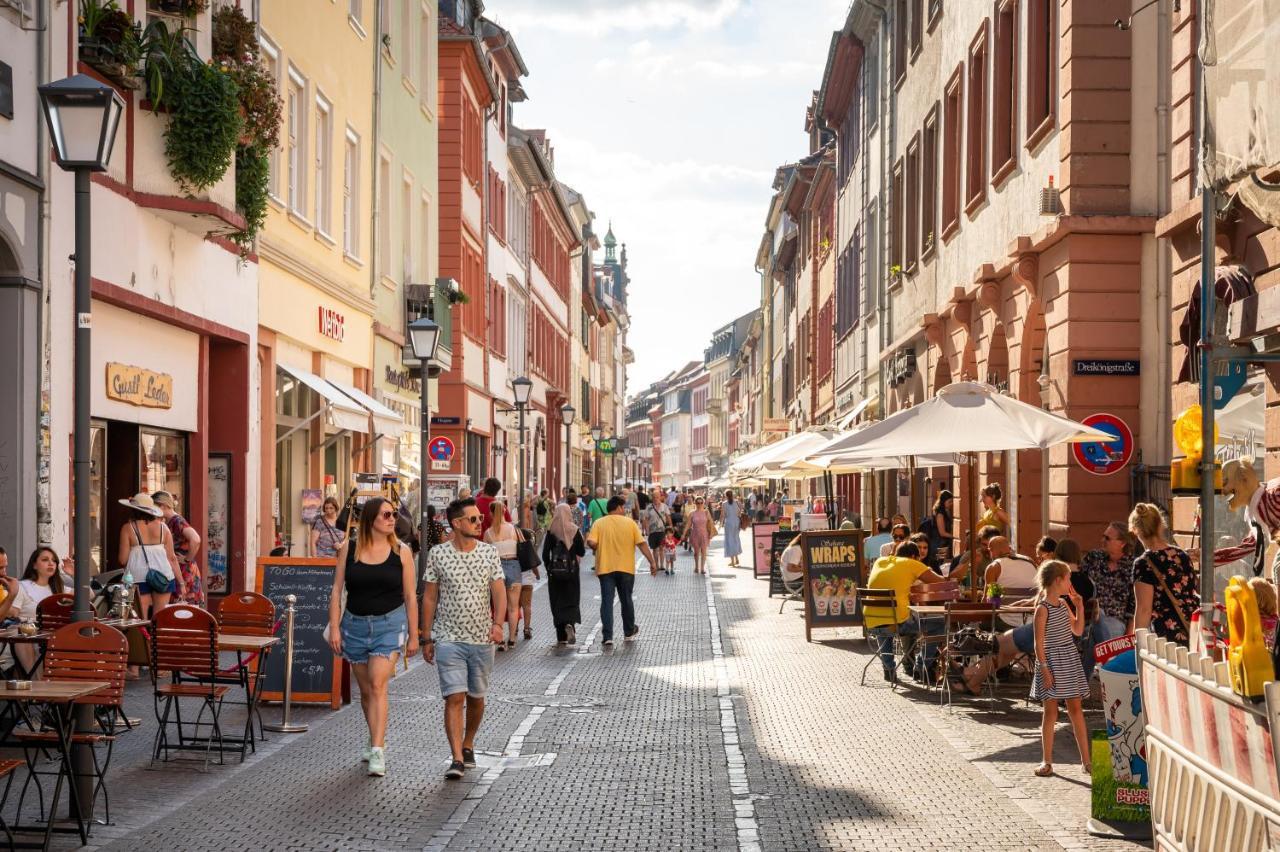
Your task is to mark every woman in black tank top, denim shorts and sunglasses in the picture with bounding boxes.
[325,498,419,777]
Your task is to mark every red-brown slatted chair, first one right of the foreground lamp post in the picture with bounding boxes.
[151,604,230,770]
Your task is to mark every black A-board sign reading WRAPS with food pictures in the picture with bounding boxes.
[800,530,867,641]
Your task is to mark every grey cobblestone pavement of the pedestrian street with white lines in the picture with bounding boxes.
[10,539,1138,851]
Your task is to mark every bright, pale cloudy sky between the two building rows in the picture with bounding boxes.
[485,0,849,393]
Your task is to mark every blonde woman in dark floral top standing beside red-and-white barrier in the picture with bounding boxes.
[1129,503,1199,645]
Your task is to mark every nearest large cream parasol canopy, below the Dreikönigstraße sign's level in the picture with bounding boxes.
[820,381,1115,464]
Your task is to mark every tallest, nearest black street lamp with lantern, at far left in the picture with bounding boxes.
[36,74,124,820]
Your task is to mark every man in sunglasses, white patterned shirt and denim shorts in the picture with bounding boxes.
[420,498,507,780]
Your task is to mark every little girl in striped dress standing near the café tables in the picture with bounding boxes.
[1032,559,1092,778]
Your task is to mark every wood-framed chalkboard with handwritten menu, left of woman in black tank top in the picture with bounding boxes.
[257,556,343,709]
